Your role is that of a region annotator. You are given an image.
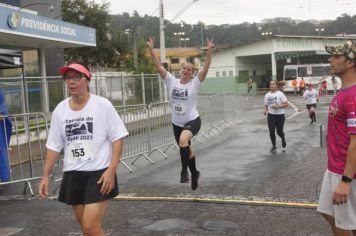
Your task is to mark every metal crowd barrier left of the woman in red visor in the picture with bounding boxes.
[0,113,48,195]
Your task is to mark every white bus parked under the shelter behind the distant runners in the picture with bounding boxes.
[283,63,341,92]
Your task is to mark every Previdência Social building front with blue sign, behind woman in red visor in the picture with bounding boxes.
[0,0,96,114]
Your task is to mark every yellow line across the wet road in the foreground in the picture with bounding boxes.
[114,195,318,208]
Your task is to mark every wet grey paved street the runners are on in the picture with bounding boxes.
[0,95,331,235]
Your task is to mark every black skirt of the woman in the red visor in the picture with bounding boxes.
[58,169,119,205]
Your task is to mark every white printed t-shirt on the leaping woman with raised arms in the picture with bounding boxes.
[164,72,201,127]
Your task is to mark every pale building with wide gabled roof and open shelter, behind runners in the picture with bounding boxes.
[207,35,355,87]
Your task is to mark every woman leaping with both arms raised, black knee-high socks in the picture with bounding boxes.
[147,37,214,190]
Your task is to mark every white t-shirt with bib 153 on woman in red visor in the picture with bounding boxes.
[46,94,128,171]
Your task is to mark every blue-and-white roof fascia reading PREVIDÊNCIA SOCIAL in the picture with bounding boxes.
[0,6,96,48]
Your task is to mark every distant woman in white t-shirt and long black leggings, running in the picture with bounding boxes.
[264,80,288,153]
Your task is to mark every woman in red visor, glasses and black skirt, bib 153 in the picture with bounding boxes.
[38,63,128,235]
